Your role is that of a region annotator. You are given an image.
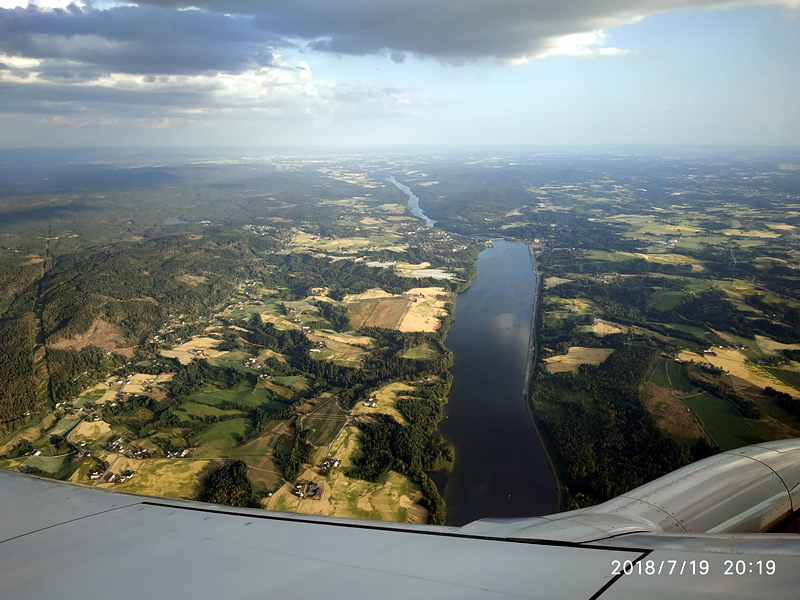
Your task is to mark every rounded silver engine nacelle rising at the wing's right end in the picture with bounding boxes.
[466,439,800,542]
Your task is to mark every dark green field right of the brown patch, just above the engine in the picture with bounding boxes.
[681,392,764,450]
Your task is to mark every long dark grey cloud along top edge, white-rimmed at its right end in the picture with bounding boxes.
[136,0,768,62]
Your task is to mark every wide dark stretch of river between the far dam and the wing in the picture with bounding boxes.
[433,240,558,526]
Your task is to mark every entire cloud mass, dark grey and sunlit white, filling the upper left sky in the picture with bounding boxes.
[0,0,800,145]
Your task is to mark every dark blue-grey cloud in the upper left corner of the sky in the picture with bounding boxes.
[0,6,276,81]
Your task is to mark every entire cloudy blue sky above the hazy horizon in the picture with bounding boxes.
[0,0,800,148]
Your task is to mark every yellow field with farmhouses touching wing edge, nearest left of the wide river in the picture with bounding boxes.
[266,427,427,523]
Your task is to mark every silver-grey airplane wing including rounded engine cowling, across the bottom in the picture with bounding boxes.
[0,440,800,600]
